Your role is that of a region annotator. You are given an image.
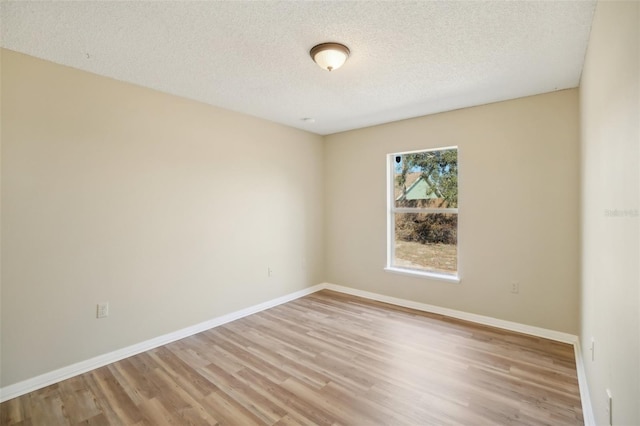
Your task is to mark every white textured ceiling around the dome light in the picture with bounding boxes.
[0,0,595,134]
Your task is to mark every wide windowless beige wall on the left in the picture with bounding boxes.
[1,51,323,386]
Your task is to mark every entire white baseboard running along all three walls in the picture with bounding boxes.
[0,283,595,426]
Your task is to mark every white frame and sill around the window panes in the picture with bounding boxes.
[384,146,460,283]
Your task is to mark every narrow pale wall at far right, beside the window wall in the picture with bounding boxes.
[580,2,640,425]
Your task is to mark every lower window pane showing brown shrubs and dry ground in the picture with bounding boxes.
[393,213,458,274]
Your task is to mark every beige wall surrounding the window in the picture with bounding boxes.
[325,90,579,334]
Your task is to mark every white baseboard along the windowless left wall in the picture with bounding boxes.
[0,284,324,402]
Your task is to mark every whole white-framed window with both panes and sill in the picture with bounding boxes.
[387,147,458,281]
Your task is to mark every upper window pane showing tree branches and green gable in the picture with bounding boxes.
[394,148,458,208]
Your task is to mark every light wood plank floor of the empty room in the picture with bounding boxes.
[0,290,583,426]
